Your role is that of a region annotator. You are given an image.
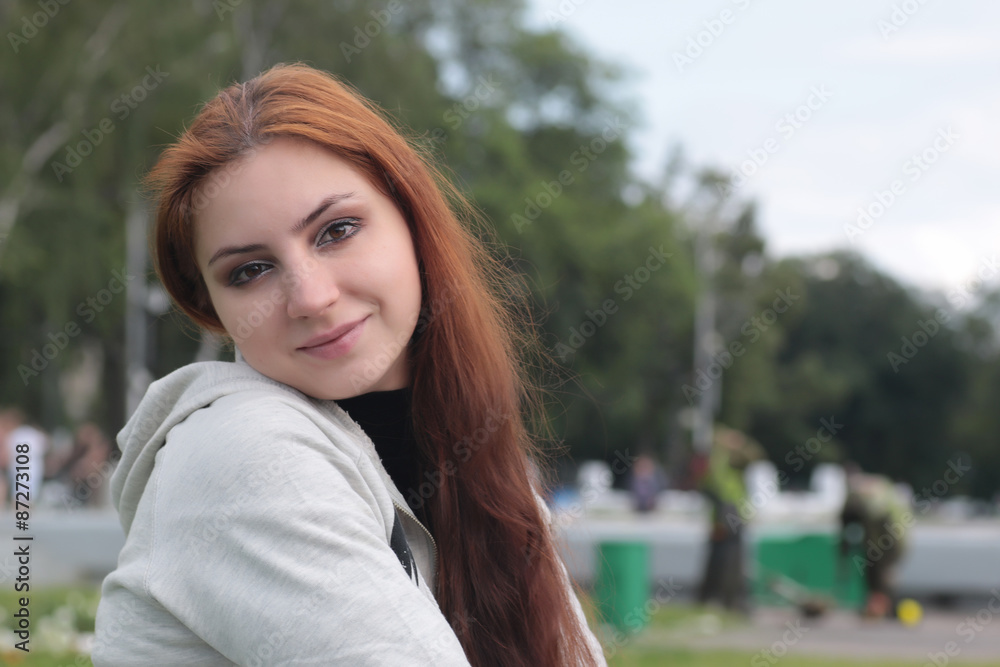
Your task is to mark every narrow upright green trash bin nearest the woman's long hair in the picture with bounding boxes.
[594,541,650,632]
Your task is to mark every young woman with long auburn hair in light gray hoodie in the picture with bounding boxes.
[93,65,604,667]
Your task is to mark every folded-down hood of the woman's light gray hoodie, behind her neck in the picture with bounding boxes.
[111,355,294,535]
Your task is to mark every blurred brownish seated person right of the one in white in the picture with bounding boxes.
[48,422,113,507]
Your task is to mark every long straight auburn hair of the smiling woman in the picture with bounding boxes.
[147,64,594,667]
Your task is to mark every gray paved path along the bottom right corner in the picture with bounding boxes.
[635,599,1000,667]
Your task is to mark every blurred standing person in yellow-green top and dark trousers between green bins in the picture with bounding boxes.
[698,426,763,613]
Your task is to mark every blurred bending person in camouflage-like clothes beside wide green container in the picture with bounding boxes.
[840,463,913,619]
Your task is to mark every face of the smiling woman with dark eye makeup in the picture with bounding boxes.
[195,137,421,399]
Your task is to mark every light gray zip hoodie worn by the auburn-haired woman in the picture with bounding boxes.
[92,361,603,667]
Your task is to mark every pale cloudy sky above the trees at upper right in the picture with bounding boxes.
[529,0,1000,293]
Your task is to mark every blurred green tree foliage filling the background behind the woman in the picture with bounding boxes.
[0,0,1000,496]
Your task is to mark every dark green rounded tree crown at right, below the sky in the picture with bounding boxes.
[727,254,969,491]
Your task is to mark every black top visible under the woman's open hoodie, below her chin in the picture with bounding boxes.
[337,389,434,534]
